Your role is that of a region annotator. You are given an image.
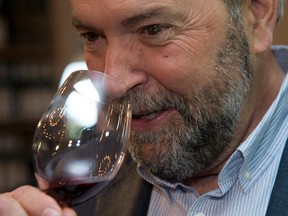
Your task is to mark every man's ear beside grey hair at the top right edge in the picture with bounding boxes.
[250,0,279,54]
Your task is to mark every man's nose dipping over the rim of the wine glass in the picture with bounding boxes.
[104,36,147,95]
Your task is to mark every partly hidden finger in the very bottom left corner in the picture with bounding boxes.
[0,193,28,216]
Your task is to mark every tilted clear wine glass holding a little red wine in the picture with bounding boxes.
[33,70,131,206]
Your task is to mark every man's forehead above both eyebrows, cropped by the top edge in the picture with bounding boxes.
[71,0,223,25]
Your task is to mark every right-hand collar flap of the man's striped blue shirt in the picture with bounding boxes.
[237,72,288,192]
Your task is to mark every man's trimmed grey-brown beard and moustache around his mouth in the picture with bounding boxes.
[128,19,252,182]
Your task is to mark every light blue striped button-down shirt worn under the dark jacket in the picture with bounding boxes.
[138,46,288,216]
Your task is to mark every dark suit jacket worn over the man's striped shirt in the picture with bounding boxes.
[76,140,288,216]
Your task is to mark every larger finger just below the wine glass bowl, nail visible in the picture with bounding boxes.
[11,186,76,216]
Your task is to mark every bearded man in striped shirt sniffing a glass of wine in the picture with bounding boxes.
[0,0,288,216]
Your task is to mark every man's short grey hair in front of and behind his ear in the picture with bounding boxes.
[223,0,286,23]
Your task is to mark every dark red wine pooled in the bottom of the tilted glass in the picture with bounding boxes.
[44,181,109,207]
